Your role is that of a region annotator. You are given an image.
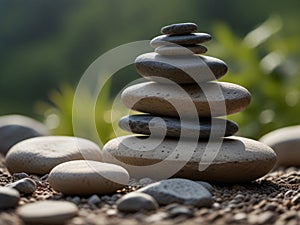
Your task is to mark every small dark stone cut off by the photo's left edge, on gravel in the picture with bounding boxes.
[0,187,20,209]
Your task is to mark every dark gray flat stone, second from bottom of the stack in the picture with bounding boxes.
[119,114,238,138]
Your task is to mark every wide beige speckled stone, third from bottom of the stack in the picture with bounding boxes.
[121,82,251,118]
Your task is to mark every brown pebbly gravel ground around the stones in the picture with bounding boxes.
[0,157,300,225]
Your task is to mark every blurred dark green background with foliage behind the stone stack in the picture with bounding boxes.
[0,0,300,142]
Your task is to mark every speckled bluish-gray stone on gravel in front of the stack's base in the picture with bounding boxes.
[137,178,213,207]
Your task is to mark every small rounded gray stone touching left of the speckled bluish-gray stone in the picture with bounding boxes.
[117,192,158,213]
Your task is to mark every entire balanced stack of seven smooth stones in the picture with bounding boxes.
[103,23,276,183]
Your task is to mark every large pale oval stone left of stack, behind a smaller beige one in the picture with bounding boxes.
[5,136,101,174]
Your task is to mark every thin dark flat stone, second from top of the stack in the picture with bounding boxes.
[150,33,211,48]
